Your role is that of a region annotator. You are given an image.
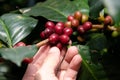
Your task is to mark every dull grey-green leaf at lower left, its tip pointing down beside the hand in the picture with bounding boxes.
[0,45,38,66]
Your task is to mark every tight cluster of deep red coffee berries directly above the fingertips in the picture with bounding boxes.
[40,21,73,49]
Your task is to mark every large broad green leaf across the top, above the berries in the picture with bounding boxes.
[20,0,88,22]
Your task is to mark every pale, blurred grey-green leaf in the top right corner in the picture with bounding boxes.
[103,0,120,27]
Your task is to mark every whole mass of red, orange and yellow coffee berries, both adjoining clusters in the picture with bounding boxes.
[40,11,92,48]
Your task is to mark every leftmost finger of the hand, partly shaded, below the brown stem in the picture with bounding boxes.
[31,45,50,68]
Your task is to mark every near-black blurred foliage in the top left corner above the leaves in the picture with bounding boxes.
[0,0,45,15]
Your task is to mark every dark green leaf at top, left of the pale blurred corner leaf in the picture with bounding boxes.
[89,0,104,18]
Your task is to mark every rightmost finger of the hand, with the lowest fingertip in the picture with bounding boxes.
[64,54,82,80]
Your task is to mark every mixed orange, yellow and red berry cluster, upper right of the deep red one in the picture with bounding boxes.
[65,11,92,34]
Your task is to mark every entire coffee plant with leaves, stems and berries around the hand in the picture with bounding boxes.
[0,0,120,80]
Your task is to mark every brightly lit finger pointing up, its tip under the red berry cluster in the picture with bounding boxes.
[40,47,60,74]
